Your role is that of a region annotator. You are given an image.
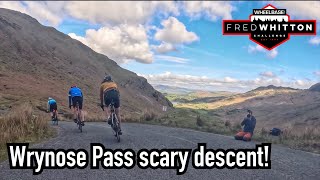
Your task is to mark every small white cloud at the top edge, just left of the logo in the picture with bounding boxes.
[182,1,236,21]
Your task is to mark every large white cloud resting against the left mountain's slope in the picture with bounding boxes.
[69,24,153,63]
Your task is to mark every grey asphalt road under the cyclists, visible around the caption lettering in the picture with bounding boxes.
[0,122,320,180]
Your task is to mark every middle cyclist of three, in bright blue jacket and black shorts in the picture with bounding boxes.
[69,85,84,126]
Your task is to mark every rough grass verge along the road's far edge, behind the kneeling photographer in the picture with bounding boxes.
[140,108,320,154]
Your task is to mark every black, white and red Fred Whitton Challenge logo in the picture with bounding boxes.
[222,4,316,50]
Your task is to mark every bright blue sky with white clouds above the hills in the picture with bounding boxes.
[0,1,320,92]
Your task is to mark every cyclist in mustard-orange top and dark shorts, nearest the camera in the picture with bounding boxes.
[100,75,122,135]
